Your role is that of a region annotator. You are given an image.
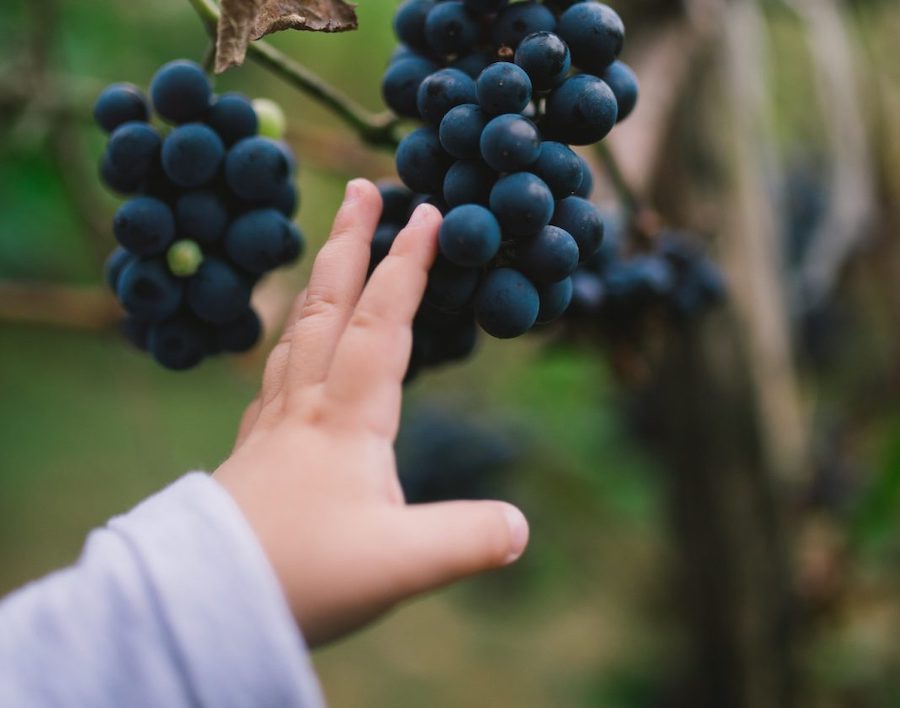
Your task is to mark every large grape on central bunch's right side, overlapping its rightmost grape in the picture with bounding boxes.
[546,74,619,145]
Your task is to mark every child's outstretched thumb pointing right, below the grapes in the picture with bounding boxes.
[395,501,528,595]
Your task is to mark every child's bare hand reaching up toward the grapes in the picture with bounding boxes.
[214,180,528,645]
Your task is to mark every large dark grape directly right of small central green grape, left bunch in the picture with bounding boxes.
[225,208,297,275]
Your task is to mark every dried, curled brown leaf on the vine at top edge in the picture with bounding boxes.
[216,0,357,73]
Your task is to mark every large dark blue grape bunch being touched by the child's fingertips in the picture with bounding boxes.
[373,0,638,372]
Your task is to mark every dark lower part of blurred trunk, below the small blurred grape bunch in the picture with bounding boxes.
[642,316,796,708]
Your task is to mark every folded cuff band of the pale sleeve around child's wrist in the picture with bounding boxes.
[109,472,325,708]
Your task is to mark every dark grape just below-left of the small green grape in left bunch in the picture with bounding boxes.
[116,257,184,322]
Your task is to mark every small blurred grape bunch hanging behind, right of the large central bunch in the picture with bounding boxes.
[566,217,725,330]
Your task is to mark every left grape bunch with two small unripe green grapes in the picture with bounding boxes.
[94,60,304,370]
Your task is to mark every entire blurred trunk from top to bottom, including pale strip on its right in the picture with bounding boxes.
[613,0,808,708]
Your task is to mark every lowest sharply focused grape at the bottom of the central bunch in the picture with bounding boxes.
[475,268,541,339]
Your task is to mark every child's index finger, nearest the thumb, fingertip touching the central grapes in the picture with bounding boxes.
[325,204,441,438]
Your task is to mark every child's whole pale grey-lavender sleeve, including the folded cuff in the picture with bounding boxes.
[0,472,324,708]
